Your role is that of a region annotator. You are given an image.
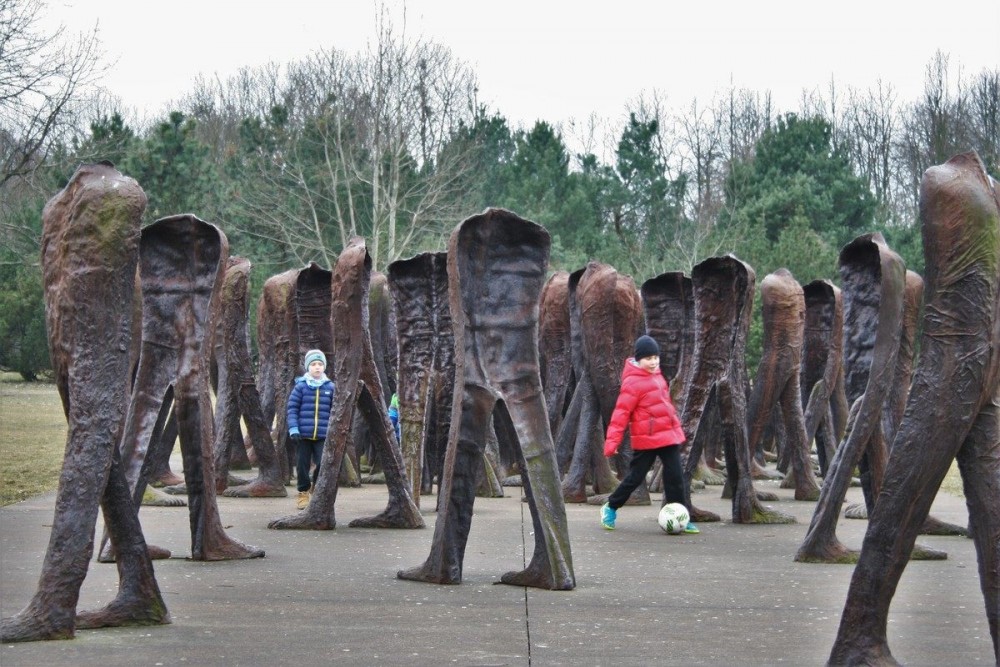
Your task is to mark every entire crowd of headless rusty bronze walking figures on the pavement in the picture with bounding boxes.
[0,153,1000,664]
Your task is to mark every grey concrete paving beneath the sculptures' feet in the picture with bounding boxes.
[0,472,994,667]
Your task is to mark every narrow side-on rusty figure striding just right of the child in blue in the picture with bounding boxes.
[268,237,424,530]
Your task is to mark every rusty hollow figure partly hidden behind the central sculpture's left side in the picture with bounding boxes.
[388,252,455,506]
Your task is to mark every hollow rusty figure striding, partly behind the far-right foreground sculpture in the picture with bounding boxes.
[795,233,906,563]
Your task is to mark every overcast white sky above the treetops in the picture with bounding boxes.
[41,0,1000,132]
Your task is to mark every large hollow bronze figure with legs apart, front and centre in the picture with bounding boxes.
[397,209,576,590]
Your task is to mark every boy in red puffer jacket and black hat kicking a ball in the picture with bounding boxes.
[601,336,701,534]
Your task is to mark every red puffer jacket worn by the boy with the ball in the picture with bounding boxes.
[604,358,684,456]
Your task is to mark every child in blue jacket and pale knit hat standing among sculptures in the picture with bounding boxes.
[288,350,336,510]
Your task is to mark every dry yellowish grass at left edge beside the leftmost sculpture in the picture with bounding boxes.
[0,373,66,507]
